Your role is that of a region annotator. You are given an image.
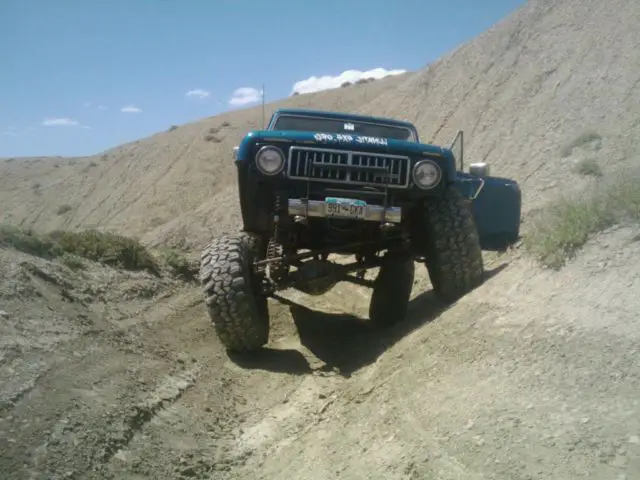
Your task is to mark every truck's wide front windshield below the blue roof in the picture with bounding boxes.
[272,115,416,142]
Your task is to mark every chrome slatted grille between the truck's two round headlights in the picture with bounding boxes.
[287,147,411,188]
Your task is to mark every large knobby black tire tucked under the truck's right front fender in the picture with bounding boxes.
[422,187,484,303]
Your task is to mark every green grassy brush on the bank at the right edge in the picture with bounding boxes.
[524,172,640,268]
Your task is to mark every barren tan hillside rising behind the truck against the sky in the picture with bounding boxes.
[0,0,640,251]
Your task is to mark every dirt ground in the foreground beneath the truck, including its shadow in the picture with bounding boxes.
[0,228,640,480]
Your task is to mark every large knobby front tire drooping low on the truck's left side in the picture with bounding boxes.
[200,232,269,352]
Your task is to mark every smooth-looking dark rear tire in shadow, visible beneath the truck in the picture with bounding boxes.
[369,253,415,327]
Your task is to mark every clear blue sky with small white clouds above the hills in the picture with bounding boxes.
[0,0,525,157]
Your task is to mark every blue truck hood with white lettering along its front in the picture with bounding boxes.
[240,130,450,157]
